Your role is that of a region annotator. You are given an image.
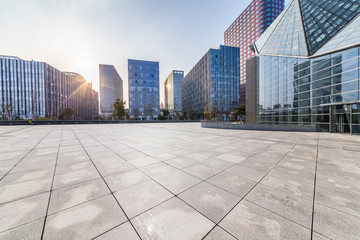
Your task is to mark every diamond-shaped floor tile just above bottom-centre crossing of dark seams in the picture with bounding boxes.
[179,182,240,223]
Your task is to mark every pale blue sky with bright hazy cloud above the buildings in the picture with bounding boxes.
[0,0,289,107]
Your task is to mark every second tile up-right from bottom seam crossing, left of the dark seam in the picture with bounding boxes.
[206,172,256,198]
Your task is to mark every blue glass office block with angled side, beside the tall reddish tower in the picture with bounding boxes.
[182,46,240,117]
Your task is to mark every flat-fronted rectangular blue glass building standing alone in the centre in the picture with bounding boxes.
[128,59,160,120]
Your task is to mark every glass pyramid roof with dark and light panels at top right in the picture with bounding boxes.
[254,0,360,57]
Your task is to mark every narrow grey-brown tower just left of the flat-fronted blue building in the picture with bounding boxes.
[99,64,124,114]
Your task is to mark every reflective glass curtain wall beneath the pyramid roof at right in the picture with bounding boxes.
[258,47,360,133]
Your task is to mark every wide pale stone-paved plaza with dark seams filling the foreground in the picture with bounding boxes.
[0,123,360,240]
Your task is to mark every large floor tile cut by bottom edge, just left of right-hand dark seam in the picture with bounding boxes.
[220,200,311,240]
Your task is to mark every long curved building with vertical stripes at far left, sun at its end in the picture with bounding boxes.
[0,56,99,119]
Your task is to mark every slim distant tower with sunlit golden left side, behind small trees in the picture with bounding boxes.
[165,70,184,112]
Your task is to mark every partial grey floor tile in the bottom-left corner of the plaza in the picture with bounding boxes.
[0,218,45,240]
